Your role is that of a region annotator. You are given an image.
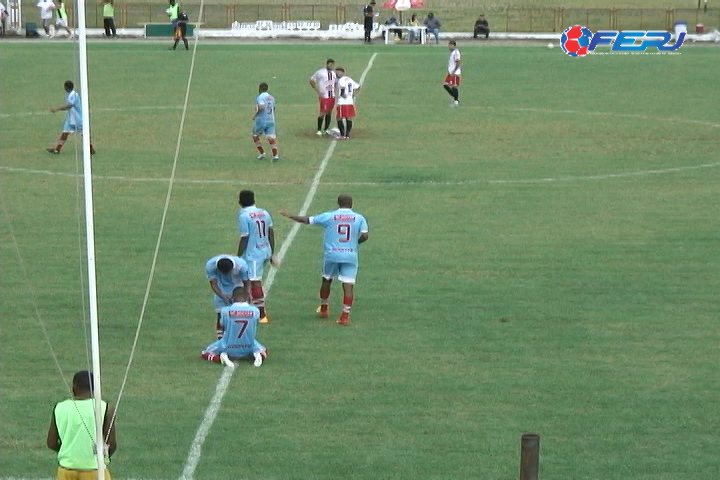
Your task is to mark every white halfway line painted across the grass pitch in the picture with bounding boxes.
[180,53,377,480]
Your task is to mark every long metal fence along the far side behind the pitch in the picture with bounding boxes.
[16,0,720,32]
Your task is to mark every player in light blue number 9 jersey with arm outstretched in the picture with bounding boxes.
[280,195,368,325]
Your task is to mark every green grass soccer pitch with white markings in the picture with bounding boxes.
[0,41,720,480]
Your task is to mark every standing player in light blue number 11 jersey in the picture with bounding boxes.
[238,190,279,323]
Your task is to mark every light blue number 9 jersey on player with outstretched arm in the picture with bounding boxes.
[310,208,368,265]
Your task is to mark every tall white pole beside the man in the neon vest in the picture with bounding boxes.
[76,0,105,480]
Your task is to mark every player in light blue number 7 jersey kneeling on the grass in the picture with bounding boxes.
[200,287,267,368]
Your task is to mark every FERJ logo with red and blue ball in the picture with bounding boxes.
[560,25,685,57]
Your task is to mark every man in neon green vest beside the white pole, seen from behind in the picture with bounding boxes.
[47,370,117,480]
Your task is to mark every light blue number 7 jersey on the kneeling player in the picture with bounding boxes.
[205,302,265,358]
